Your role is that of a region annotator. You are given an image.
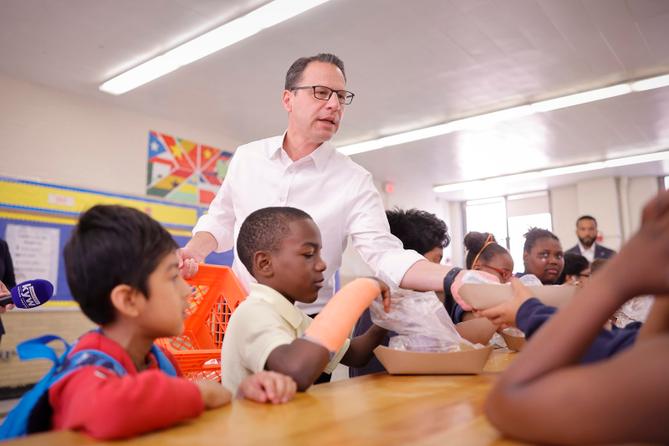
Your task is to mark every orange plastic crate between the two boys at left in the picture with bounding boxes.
[156,265,246,381]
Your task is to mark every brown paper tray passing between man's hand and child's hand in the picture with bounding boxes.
[460,283,576,310]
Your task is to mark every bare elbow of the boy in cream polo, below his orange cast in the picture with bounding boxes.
[265,339,330,392]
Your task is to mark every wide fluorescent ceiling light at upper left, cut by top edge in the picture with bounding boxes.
[99,0,328,95]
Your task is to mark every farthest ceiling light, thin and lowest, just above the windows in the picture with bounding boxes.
[432,150,669,192]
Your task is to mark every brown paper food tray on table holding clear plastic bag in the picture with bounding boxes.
[374,345,492,375]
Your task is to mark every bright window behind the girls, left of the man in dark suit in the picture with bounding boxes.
[465,191,553,272]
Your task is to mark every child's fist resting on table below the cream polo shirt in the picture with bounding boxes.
[237,372,297,404]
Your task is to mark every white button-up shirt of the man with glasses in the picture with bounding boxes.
[193,135,425,314]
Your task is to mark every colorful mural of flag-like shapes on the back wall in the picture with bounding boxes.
[146,131,232,205]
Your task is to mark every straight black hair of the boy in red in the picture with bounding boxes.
[63,205,177,325]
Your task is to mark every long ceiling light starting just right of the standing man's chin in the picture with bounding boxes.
[337,74,669,156]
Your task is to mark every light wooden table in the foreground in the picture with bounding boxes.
[9,351,519,446]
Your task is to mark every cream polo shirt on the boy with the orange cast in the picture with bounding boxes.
[221,283,350,394]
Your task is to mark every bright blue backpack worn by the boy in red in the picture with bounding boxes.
[0,335,177,440]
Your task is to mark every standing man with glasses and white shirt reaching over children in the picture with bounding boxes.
[180,54,451,314]
